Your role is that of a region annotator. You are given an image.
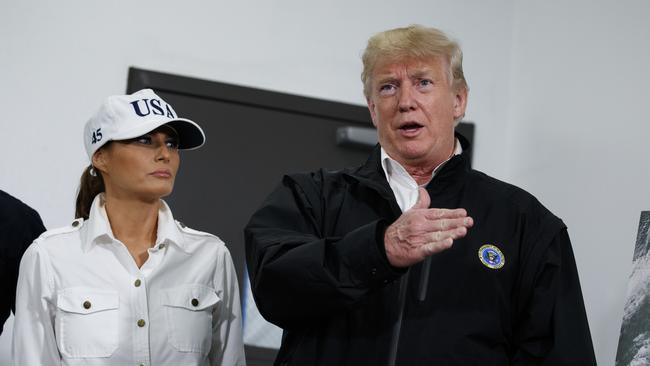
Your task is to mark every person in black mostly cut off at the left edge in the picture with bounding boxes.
[0,190,45,334]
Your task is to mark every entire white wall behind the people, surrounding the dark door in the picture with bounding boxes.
[0,0,649,364]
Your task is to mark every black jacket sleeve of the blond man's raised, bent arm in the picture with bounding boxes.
[245,176,403,329]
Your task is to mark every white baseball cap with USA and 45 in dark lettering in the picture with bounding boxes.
[84,89,205,161]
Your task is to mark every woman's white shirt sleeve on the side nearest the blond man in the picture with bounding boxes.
[209,247,246,366]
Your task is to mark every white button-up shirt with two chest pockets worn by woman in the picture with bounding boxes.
[13,196,245,366]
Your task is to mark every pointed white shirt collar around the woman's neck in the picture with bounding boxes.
[81,193,188,252]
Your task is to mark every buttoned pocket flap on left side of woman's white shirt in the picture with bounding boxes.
[56,287,120,314]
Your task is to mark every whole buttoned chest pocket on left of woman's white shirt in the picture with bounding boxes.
[55,287,119,358]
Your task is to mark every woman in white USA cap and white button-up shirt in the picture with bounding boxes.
[13,89,245,366]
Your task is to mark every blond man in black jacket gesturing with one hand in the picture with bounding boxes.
[245,26,595,366]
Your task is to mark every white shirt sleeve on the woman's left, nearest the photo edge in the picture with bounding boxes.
[12,243,61,366]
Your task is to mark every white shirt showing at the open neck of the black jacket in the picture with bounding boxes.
[381,139,463,212]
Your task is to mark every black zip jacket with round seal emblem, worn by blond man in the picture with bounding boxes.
[245,137,596,366]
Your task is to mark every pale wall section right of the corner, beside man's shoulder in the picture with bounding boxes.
[507,0,650,365]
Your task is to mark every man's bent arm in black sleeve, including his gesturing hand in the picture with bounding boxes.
[245,176,473,329]
